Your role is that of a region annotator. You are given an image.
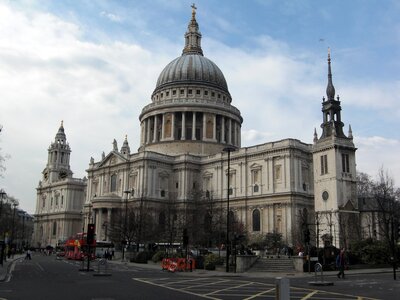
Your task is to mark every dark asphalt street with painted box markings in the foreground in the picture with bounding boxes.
[0,255,400,300]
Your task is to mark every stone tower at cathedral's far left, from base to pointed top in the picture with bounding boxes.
[33,122,86,248]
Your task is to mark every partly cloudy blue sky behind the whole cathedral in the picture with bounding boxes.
[0,0,400,213]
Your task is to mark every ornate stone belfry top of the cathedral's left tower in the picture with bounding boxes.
[43,121,73,183]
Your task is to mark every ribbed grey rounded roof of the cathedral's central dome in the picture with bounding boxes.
[156,53,228,92]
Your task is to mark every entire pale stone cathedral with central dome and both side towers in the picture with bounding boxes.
[35,8,357,247]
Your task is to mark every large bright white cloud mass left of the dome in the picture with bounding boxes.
[0,4,168,212]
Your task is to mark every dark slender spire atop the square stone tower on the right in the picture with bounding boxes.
[321,48,346,139]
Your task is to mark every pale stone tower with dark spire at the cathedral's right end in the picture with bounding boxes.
[313,50,358,247]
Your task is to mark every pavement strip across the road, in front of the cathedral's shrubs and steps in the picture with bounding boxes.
[109,260,394,278]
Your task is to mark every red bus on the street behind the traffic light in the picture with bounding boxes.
[64,233,96,260]
